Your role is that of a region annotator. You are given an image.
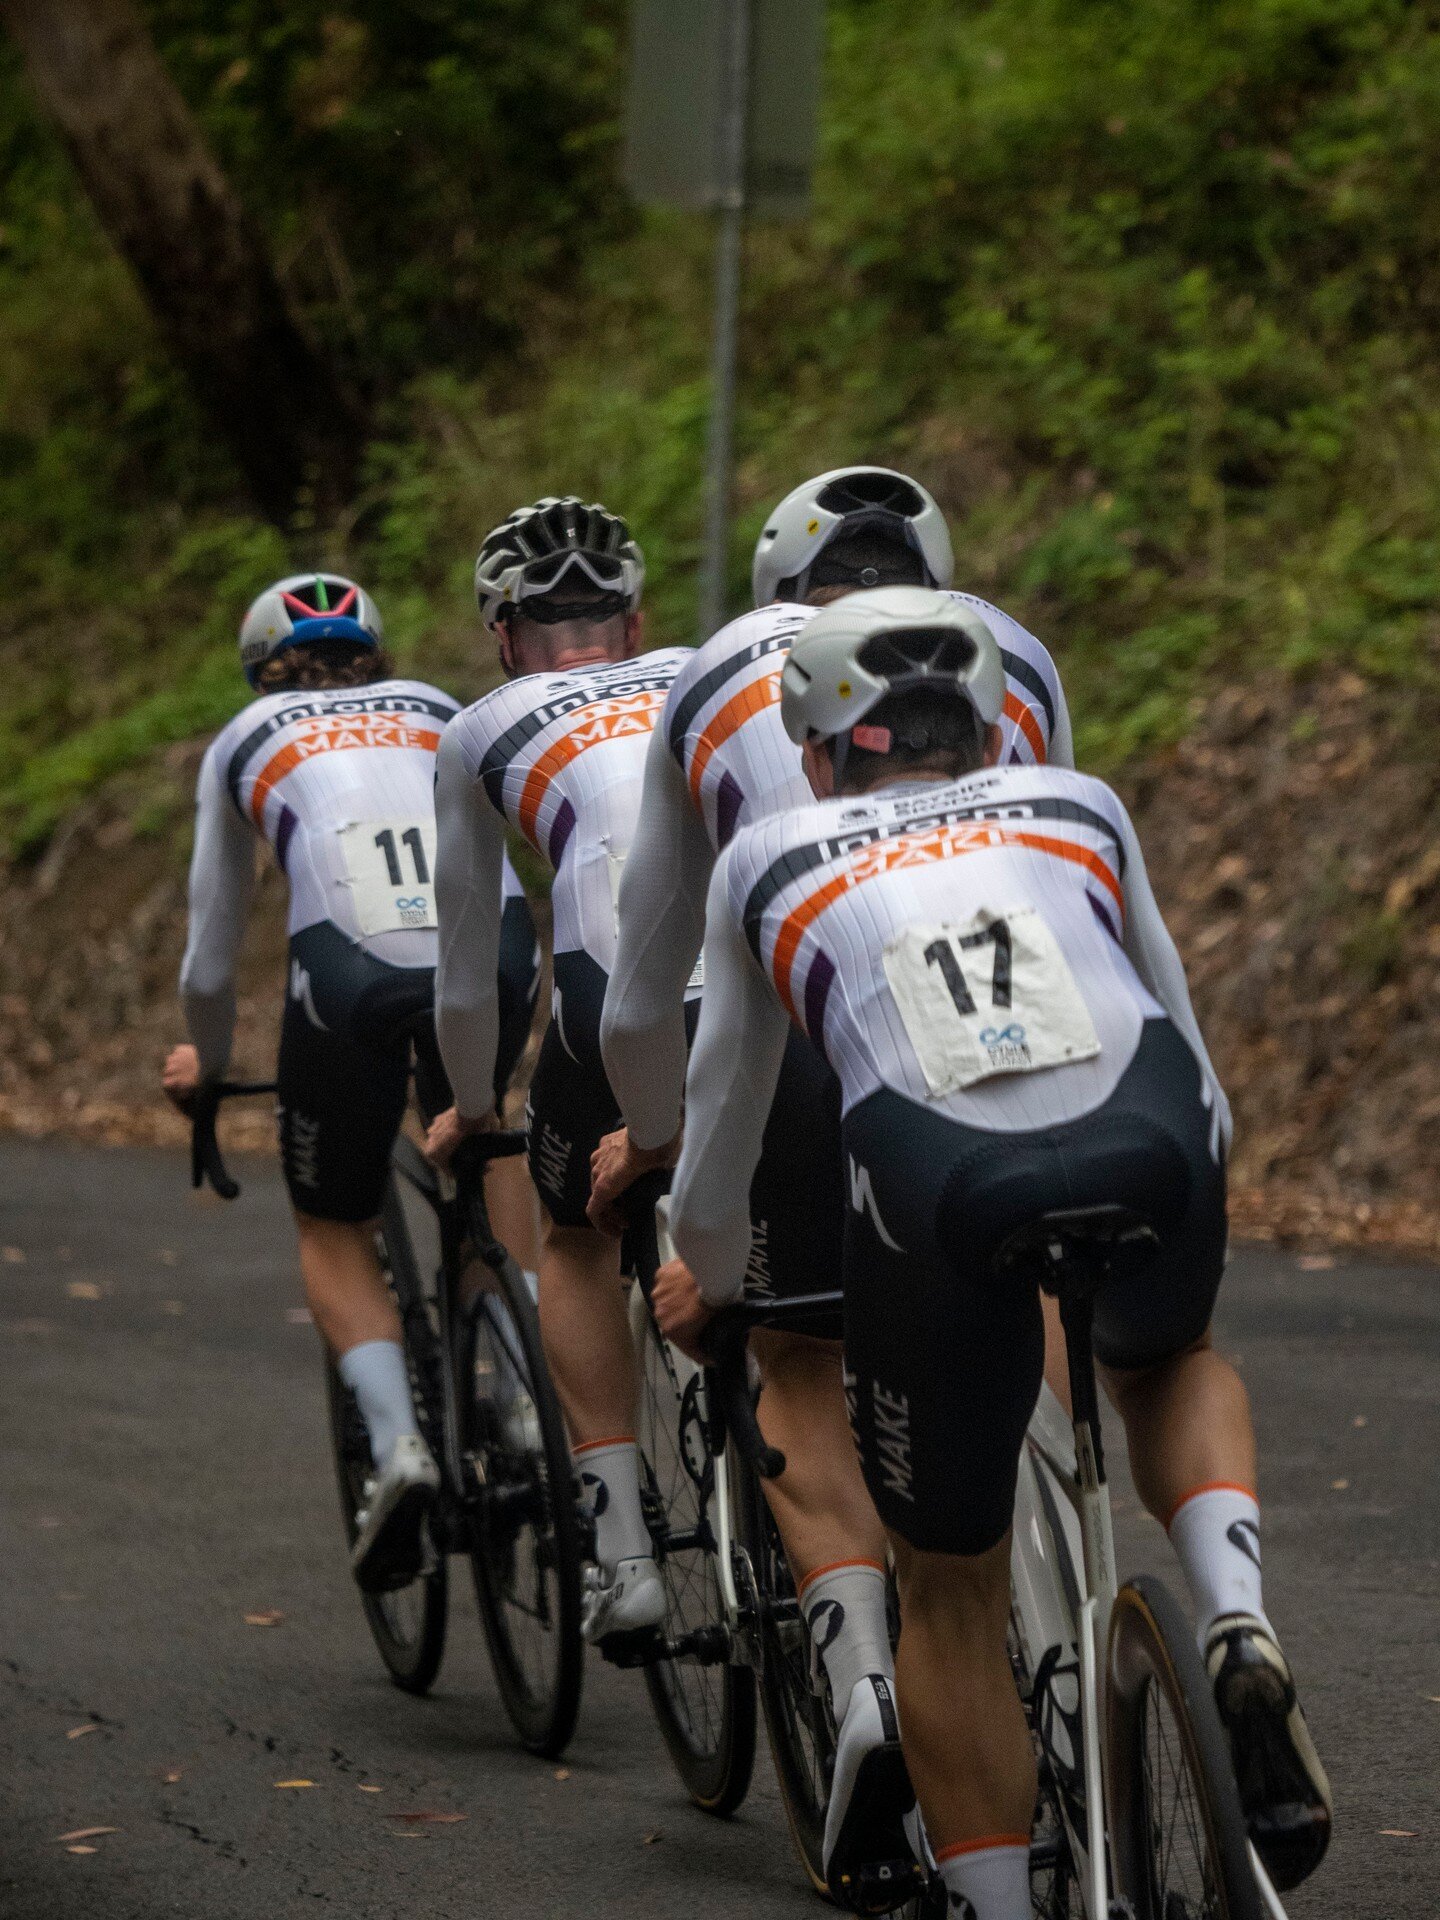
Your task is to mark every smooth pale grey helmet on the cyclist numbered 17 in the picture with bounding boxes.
[780,588,1004,753]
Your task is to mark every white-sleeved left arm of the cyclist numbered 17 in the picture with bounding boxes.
[670,860,789,1308]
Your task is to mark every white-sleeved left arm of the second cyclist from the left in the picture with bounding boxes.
[436,728,505,1125]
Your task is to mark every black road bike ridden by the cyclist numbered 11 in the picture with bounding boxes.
[192,1081,586,1757]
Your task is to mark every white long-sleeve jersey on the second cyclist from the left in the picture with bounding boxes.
[436,647,693,1117]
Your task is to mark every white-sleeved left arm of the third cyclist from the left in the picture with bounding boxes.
[601,722,714,1148]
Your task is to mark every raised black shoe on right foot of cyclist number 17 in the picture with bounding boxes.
[1206,1613,1332,1893]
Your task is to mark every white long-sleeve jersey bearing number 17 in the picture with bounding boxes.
[672,766,1229,1304]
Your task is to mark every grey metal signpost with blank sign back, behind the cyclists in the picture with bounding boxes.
[626,0,824,639]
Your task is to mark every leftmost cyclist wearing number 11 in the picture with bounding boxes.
[163,572,538,1590]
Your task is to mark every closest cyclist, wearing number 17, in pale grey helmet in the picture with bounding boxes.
[655,589,1331,1920]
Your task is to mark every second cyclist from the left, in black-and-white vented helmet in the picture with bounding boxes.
[428,497,689,1642]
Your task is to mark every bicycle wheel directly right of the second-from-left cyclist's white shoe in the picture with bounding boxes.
[632,1296,756,1818]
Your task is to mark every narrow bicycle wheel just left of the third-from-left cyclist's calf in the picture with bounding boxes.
[735,1465,835,1893]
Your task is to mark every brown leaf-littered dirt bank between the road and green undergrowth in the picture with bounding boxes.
[0,678,1440,1256]
